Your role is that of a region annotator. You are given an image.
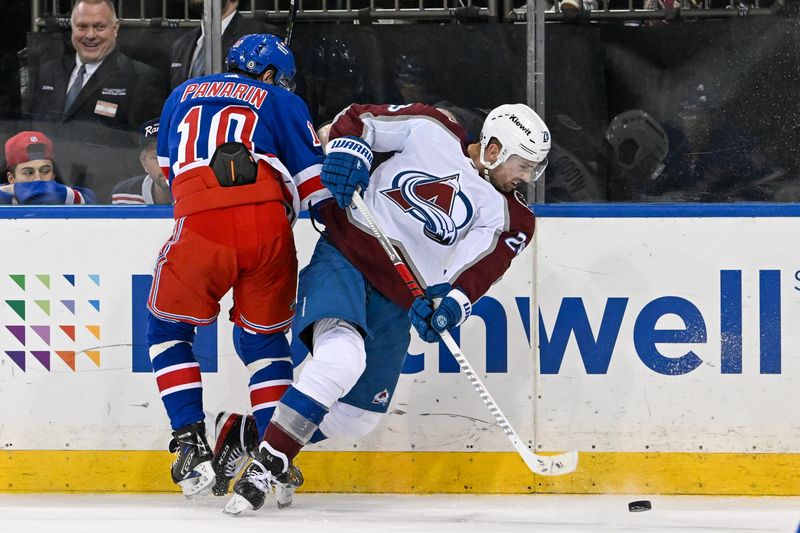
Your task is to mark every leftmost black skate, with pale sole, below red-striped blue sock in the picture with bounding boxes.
[169,422,214,498]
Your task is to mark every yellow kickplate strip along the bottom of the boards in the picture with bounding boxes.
[0,450,800,496]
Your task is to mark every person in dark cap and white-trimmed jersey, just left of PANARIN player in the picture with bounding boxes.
[111,118,172,205]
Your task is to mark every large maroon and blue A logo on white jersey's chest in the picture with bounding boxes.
[381,170,473,246]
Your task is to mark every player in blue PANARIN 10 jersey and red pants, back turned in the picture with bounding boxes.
[147,34,324,496]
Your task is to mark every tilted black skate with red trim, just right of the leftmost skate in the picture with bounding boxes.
[211,411,258,496]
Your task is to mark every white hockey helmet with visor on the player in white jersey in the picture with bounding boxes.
[480,104,550,181]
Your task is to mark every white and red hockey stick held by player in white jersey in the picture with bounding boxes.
[353,191,578,476]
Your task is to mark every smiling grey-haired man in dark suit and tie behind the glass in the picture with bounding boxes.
[31,0,166,202]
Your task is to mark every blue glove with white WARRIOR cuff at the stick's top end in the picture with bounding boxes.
[320,135,372,209]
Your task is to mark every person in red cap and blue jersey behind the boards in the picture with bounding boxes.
[0,131,97,205]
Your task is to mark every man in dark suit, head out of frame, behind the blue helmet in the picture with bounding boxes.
[170,0,283,89]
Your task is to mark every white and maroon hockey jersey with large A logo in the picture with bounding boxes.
[320,104,534,308]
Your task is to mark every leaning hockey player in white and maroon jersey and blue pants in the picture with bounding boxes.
[226,104,550,514]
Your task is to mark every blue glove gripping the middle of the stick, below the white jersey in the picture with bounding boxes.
[408,283,472,342]
